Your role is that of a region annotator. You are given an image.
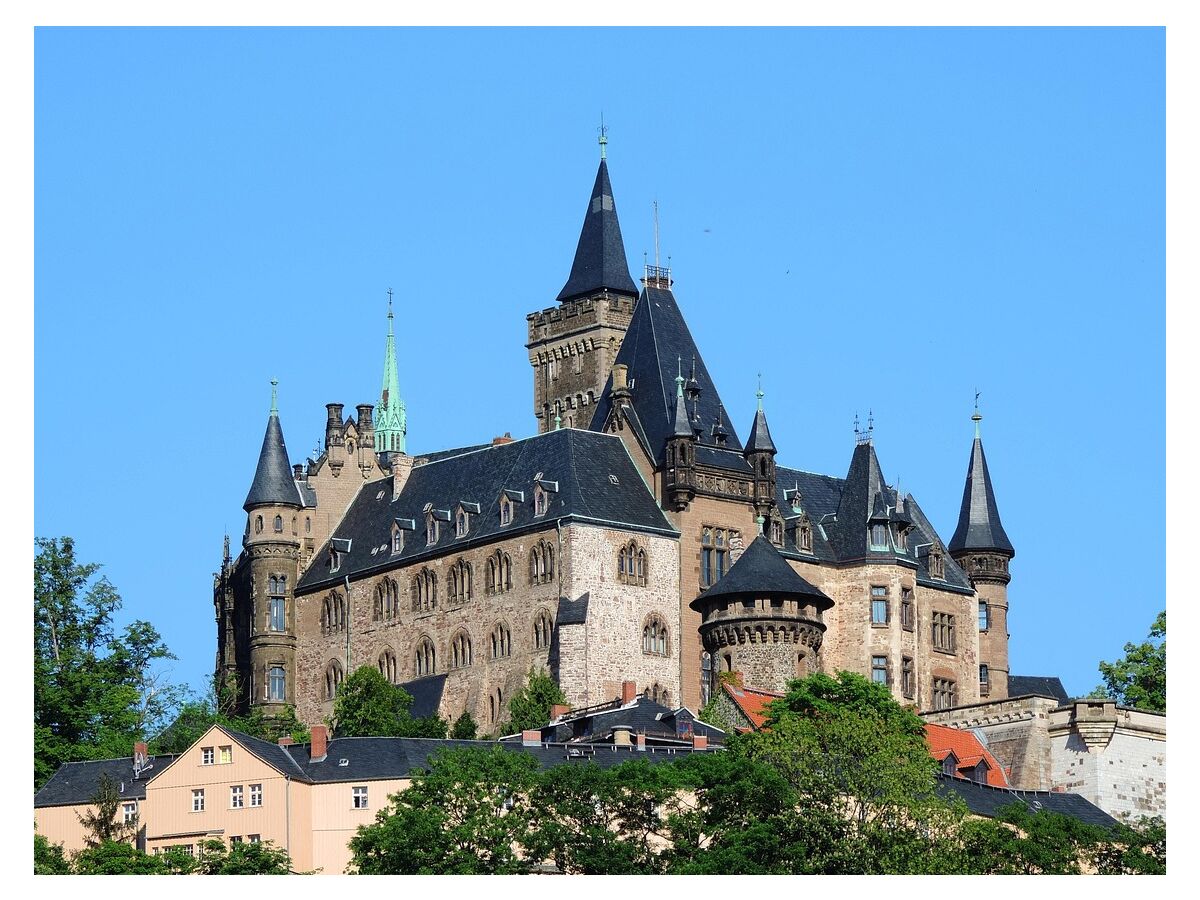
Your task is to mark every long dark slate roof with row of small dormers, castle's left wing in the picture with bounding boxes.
[296,428,678,593]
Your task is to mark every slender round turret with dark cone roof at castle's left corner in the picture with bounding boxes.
[242,379,302,713]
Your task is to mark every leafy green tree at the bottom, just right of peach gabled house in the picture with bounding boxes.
[349,746,538,875]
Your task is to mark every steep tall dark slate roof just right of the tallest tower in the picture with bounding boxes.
[590,287,744,464]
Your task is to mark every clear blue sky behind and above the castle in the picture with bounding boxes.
[34,28,1165,694]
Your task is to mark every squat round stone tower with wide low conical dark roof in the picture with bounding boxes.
[690,534,833,692]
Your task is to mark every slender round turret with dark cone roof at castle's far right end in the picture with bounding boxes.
[947,406,1016,700]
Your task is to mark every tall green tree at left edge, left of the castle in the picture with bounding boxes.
[34,538,185,787]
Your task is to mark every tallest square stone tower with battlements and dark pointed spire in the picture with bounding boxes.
[526,133,637,433]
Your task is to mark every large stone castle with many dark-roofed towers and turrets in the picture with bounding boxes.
[214,138,1015,731]
